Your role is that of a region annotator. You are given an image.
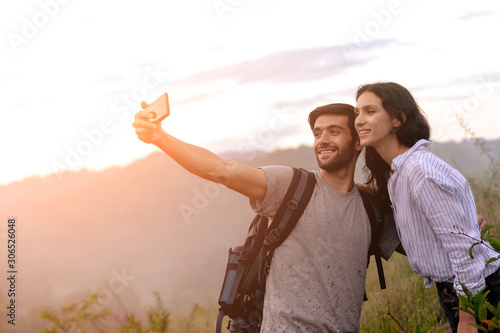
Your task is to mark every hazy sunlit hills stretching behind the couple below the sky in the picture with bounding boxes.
[0,140,500,328]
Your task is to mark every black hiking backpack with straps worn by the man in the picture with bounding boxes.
[216,168,385,333]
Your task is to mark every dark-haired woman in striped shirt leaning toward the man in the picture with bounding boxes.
[355,82,500,333]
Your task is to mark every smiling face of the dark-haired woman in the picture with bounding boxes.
[354,91,401,148]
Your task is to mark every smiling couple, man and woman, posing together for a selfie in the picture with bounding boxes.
[134,83,500,332]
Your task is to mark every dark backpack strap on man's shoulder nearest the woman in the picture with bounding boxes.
[359,190,386,289]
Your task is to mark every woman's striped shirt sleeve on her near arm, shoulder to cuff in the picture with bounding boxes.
[414,177,485,295]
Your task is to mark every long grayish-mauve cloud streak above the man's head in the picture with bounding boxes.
[169,39,401,104]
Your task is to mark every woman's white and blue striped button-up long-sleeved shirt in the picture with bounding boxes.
[387,140,500,294]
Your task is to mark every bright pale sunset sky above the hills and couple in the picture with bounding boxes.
[0,0,500,185]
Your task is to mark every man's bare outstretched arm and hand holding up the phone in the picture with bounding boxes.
[133,104,267,200]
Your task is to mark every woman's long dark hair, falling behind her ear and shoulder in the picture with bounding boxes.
[356,82,431,206]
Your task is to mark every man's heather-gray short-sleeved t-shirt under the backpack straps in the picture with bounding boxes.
[250,166,399,333]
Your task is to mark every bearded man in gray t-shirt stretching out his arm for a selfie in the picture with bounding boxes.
[133,104,399,333]
